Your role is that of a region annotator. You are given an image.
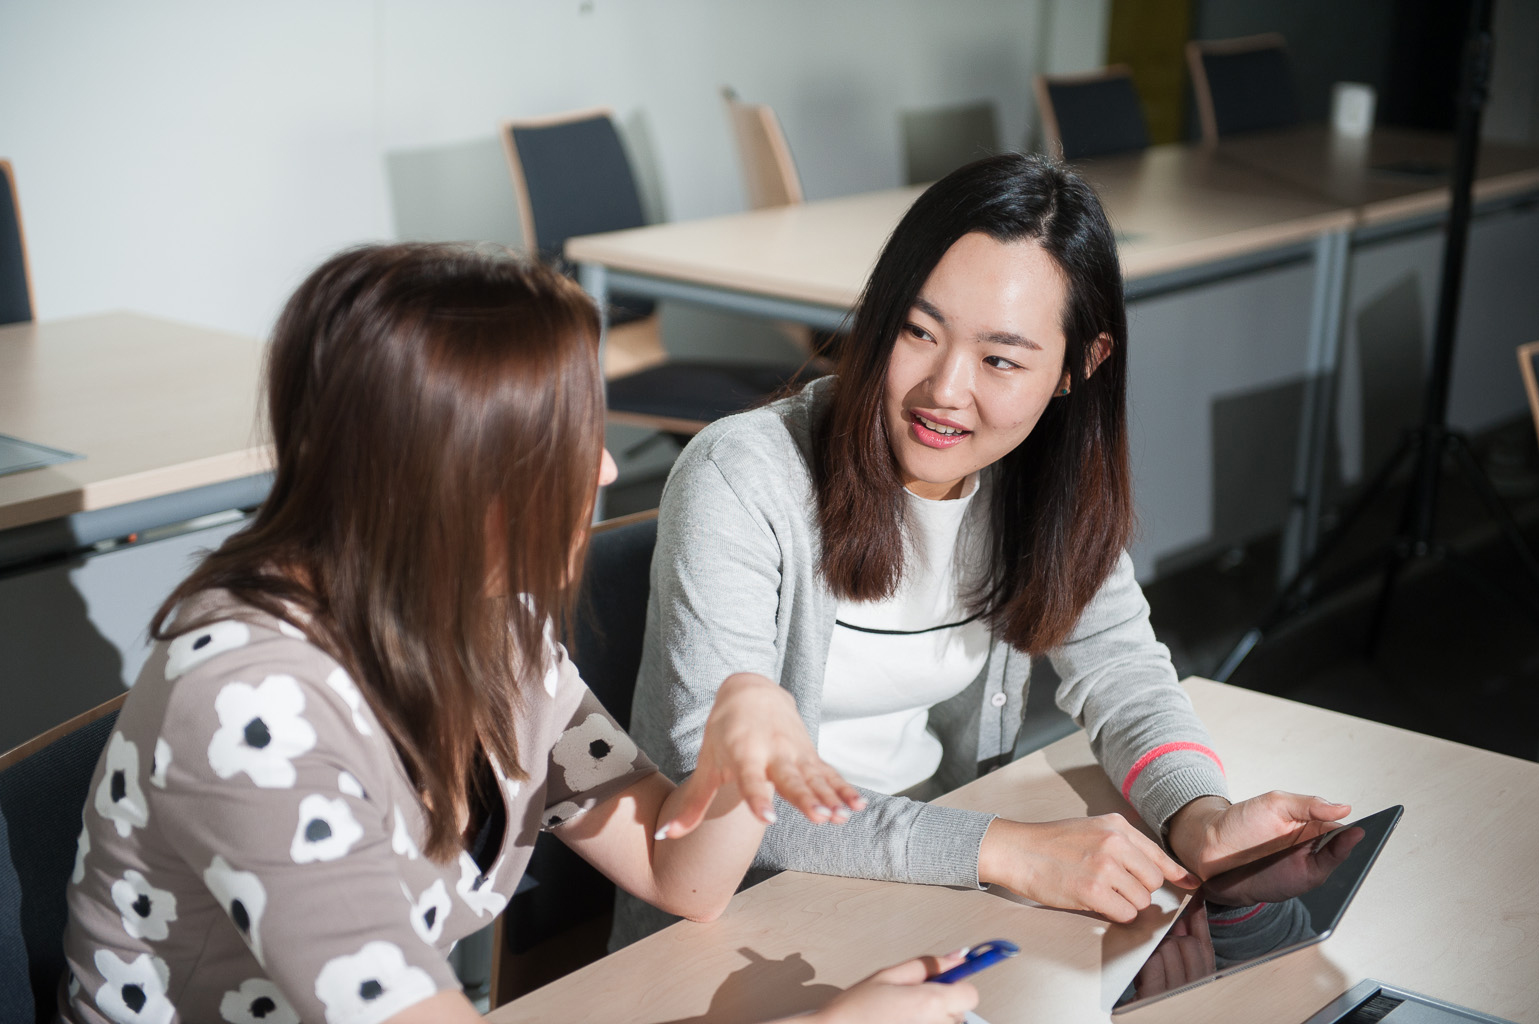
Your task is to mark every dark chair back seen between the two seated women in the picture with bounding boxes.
[503,516,657,953]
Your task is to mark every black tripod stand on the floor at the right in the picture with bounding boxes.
[1214,0,1539,681]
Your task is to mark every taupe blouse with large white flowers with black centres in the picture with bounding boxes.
[62,591,656,1024]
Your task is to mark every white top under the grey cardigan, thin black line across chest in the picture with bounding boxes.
[817,474,990,793]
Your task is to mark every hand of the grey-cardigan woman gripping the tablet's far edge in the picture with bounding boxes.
[1170,790,1351,878]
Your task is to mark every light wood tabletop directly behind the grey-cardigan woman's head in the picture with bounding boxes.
[565,145,1351,308]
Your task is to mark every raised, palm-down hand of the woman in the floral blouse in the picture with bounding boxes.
[657,673,865,839]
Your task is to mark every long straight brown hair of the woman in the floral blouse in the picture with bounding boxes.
[152,245,603,859]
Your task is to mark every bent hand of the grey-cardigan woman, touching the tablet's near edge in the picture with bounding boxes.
[977,815,1199,924]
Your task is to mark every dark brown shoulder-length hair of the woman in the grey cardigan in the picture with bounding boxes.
[813,154,1133,653]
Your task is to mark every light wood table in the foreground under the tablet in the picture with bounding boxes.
[489,679,1539,1024]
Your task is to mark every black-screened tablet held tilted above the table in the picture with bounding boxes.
[1111,805,1405,1013]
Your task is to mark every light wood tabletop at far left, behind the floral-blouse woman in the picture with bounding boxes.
[0,313,269,530]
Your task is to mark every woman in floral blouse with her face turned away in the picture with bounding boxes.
[62,245,976,1024]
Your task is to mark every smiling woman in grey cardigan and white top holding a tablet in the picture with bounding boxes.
[616,156,1348,942]
